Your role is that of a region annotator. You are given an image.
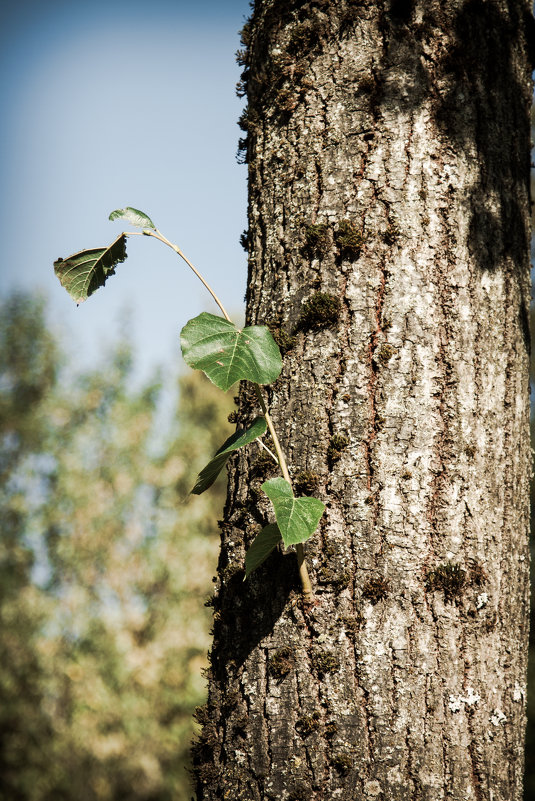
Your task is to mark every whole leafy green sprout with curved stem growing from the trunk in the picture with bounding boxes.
[54,212,318,602]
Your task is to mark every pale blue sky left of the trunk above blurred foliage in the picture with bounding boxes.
[0,0,250,376]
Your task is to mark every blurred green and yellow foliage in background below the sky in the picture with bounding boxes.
[0,295,232,801]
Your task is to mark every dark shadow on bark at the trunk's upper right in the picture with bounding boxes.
[377,0,534,270]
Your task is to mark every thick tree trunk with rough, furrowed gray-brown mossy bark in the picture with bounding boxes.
[194,0,532,801]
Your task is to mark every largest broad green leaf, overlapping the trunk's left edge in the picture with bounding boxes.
[180,312,282,392]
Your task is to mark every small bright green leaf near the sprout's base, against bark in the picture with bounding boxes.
[262,477,325,547]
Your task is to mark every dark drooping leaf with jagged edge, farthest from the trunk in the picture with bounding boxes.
[54,234,126,305]
